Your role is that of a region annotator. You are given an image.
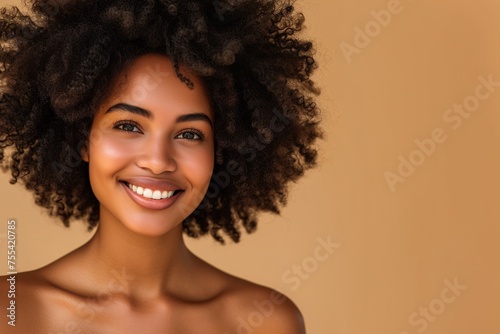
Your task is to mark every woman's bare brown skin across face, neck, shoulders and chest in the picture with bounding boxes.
[0,55,305,334]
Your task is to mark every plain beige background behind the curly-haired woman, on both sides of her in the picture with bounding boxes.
[0,0,500,334]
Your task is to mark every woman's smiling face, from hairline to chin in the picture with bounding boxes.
[82,55,214,236]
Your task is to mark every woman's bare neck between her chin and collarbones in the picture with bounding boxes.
[82,211,194,299]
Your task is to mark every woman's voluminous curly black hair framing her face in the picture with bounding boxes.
[0,0,322,243]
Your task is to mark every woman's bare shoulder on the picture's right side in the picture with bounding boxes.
[198,260,305,334]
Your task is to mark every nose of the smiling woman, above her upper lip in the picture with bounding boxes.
[136,138,177,174]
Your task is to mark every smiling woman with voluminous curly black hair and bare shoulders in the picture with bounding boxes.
[0,0,320,334]
